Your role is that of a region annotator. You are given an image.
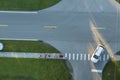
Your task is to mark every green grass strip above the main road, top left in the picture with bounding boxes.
[0,0,60,11]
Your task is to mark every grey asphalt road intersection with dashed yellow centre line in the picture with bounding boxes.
[0,0,120,80]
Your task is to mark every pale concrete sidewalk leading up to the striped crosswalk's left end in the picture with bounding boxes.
[0,52,65,59]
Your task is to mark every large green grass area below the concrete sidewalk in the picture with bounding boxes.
[0,58,72,80]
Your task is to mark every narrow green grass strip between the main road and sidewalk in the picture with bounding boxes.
[0,40,59,53]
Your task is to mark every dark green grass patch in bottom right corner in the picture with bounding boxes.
[102,61,120,80]
